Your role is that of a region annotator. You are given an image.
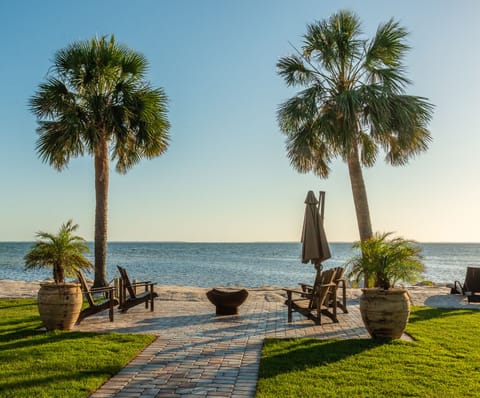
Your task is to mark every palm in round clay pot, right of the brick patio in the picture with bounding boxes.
[349,232,425,339]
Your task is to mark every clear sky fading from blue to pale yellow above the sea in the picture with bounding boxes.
[0,0,480,242]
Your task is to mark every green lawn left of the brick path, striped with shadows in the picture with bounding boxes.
[0,299,155,398]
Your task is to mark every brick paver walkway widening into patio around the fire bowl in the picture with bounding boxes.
[76,290,368,398]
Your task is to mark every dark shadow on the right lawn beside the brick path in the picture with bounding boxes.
[259,339,392,378]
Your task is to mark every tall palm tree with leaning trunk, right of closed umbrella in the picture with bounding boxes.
[277,11,433,241]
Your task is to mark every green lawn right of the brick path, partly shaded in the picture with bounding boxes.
[257,307,480,398]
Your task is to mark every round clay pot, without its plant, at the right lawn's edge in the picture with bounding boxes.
[360,288,410,339]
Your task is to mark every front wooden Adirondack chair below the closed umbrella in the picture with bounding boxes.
[284,269,338,325]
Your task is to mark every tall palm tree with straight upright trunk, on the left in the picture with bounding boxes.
[30,35,170,287]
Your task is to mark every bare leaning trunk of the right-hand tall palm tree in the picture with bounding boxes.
[348,147,373,242]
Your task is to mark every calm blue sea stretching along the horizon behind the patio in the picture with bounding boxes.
[0,242,480,287]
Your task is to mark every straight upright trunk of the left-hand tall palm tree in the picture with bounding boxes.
[93,140,110,287]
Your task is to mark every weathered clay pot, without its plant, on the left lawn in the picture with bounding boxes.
[38,283,83,330]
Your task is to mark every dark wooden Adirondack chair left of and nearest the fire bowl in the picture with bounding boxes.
[117,265,158,312]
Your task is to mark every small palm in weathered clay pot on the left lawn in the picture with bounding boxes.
[24,220,92,330]
